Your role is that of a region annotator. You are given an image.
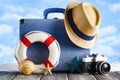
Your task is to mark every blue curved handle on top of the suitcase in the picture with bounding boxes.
[43,8,65,19]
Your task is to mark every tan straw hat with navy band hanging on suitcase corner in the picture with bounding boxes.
[64,2,101,49]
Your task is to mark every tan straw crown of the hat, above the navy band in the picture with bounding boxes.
[72,2,100,36]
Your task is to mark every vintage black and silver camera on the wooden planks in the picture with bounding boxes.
[82,54,110,74]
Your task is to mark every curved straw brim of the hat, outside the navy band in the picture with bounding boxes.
[64,2,98,49]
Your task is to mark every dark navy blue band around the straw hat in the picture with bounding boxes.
[68,9,95,41]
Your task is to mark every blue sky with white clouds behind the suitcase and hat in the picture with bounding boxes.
[0,0,120,64]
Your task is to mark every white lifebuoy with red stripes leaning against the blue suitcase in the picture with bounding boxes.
[15,31,60,73]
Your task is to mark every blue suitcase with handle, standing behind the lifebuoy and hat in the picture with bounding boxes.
[20,8,90,72]
